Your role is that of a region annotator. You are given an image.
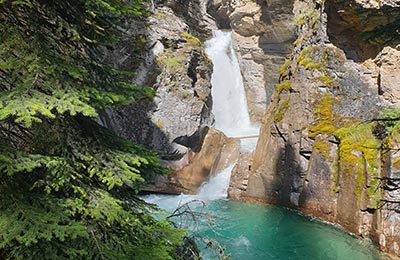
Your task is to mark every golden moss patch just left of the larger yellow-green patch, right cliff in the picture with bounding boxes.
[308,93,335,138]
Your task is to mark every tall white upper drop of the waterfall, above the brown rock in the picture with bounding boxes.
[205,30,259,146]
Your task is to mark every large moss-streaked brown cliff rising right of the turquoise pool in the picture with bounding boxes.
[231,0,400,256]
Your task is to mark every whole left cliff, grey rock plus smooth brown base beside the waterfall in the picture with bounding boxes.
[99,0,230,194]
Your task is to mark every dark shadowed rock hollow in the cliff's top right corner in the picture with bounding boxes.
[325,0,400,62]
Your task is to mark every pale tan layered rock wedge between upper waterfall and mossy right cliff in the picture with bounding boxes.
[209,0,295,122]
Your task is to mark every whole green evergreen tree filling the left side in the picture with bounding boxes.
[0,0,183,259]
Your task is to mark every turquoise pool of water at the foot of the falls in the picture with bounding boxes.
[144,193,388,260]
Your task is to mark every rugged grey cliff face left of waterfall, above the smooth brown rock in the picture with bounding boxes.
[101,4,213,154]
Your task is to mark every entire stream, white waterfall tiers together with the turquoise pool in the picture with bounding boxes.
[142,31,385,260]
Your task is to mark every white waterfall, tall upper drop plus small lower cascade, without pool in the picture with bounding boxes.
[143,30,258,206]
